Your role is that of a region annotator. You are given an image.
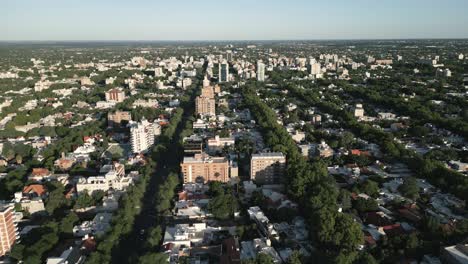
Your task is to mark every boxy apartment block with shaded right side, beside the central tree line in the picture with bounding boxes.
[250,152,286,184]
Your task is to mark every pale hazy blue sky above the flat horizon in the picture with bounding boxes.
[0,0,468,40]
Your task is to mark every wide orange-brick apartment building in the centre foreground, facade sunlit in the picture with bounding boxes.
[180,153,229,183]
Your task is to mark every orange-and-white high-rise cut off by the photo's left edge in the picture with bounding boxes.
[0,204,17,257]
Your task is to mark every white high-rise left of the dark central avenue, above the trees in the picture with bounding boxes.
[130,119,161,153]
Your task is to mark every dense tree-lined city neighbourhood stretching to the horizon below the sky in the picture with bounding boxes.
[0,39,468,264]
